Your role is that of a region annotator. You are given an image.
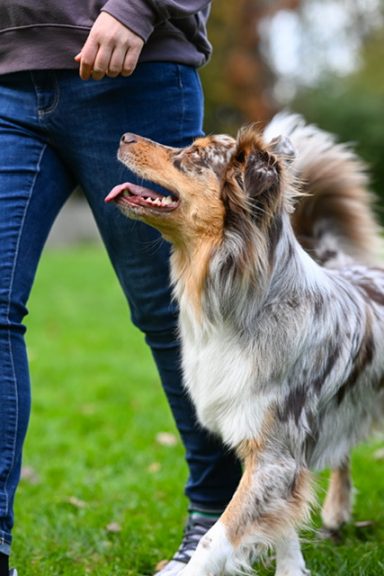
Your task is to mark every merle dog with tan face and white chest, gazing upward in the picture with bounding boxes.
[106,114,384,576]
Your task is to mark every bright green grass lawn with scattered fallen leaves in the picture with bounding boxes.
[12,247,384,576]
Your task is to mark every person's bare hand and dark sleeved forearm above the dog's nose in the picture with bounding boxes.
[75,0,210,80]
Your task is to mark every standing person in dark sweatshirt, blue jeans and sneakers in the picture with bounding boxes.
[0,0,240,576]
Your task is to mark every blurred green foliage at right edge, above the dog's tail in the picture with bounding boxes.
[291,29,384,212]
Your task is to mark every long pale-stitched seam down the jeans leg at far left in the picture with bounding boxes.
[4,144,47,512]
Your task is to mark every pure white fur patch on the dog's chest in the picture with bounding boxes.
[182,326,269,446]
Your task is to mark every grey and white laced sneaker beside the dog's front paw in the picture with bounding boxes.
[155,515,217,576]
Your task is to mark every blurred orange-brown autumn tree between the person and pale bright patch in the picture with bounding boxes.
[201,0,300,132]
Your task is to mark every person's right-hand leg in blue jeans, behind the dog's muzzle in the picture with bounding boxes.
[45,64,240,512]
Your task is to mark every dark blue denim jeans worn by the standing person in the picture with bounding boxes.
[0,63,240,554]
